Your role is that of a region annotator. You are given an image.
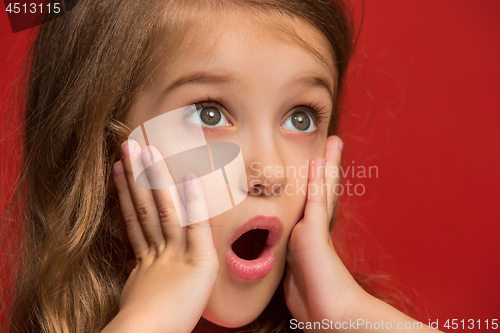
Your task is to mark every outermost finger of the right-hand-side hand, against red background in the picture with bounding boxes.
[325,135,344,222]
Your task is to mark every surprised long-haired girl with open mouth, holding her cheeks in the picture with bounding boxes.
[1,0,444,333]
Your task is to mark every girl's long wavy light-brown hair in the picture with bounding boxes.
[0,0,353,333]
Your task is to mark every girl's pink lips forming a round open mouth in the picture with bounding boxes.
[226,215,283,280]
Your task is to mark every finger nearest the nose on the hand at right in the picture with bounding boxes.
[304,157,327,232]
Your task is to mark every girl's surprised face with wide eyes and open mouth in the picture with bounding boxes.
[127,9,335,327]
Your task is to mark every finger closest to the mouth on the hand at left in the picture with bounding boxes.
[184,173,213,254]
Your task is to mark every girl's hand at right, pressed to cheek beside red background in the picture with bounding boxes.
[284,136,366,322]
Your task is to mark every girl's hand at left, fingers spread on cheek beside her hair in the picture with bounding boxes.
[103,141,219,333]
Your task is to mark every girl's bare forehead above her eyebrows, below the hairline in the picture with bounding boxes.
[156,9,336,87]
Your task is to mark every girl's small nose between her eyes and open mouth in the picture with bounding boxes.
[245,140,287,196]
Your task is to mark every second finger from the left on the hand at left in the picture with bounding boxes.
[121,140,165,251]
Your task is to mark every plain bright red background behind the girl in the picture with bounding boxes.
[0,0,500,331]
